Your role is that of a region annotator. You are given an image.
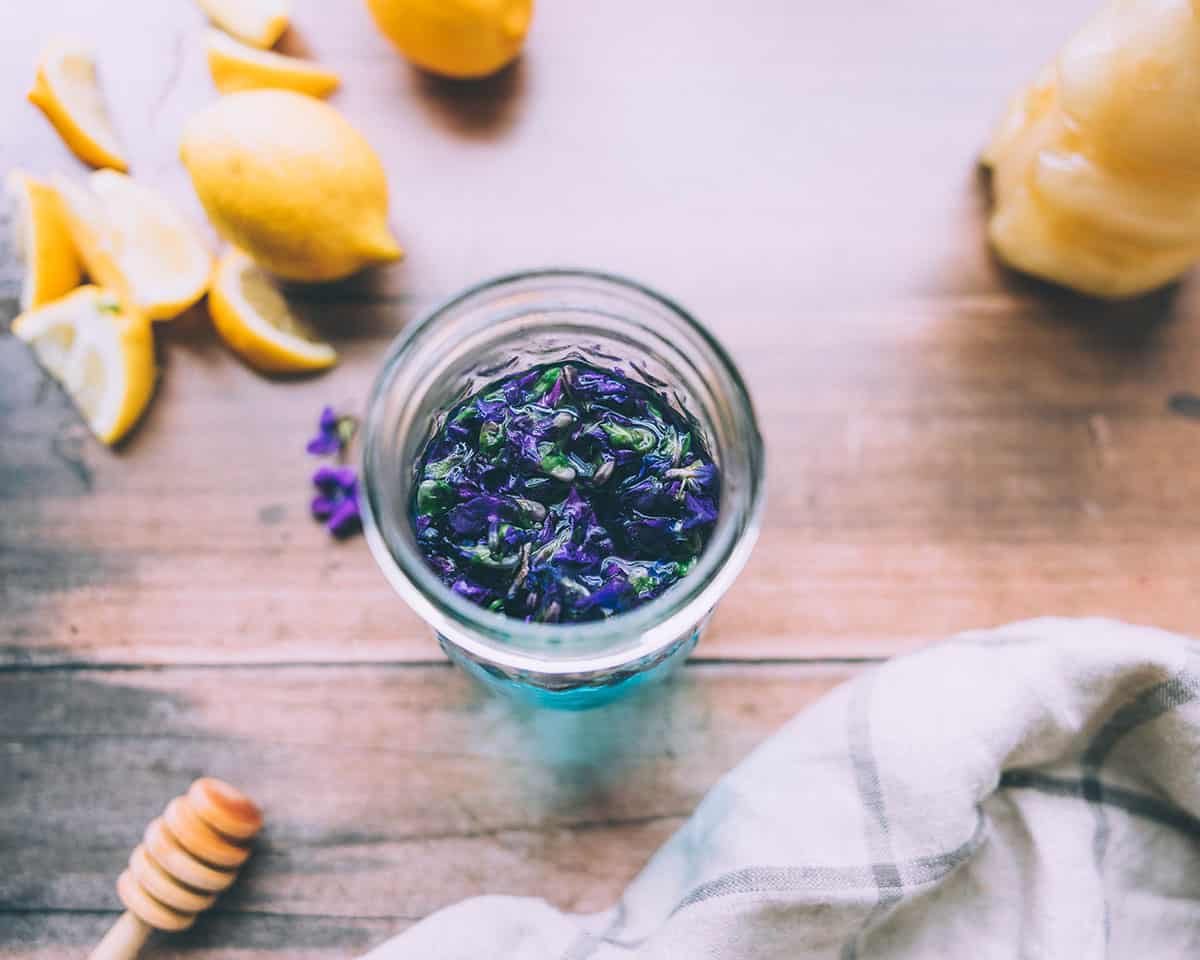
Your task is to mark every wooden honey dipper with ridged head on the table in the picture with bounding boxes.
[90,776,263,960]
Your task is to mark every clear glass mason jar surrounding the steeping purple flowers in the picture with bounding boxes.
[362,270,764,709]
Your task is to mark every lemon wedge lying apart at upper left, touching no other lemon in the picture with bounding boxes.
[29,37,130,170]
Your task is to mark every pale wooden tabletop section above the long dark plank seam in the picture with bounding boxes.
[0,0,1200,662]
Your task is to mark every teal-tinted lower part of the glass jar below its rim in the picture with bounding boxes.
[438,618,707,710]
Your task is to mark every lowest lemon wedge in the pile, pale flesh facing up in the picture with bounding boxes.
[12,287,155,444]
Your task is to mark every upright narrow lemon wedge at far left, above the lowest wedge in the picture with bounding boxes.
[7,170,83,310]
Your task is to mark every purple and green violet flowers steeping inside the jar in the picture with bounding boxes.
[412,362,720,623]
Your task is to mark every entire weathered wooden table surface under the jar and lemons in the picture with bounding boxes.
[0,0,1200,958]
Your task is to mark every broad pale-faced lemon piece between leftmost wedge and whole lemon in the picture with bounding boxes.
[54,170,212,320]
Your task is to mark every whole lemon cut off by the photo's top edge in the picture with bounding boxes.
[367,0,533,77]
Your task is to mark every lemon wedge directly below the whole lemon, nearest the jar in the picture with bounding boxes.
[209,250,337,373]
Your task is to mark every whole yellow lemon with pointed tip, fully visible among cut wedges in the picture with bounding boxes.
[180,90,402,282]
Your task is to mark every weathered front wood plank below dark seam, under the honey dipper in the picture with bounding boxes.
[0,666,848,958]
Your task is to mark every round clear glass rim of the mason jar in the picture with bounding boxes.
[360,268,766,676]
